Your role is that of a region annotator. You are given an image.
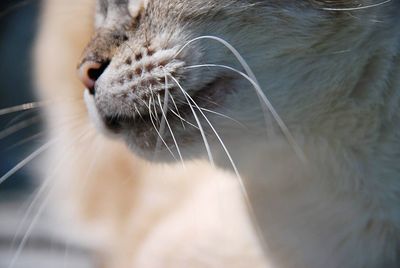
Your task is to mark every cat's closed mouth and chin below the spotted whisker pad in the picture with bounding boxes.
[84,76,234,155]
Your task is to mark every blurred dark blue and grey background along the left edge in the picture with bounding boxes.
[0,0,92,268]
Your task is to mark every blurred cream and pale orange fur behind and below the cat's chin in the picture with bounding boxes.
[34,0,269,268]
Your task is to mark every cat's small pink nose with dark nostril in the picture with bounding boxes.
[78,61,108,94]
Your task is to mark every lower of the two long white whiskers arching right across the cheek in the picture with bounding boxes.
[185,64,307,163]
